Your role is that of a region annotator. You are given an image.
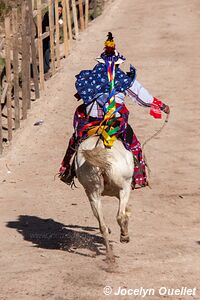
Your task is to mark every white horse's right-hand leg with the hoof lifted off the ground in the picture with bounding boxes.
[117,184,131,243]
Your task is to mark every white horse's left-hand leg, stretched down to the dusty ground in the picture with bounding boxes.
[87,193,115,261]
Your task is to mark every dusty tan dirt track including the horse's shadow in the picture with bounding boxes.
[0,0,200,300]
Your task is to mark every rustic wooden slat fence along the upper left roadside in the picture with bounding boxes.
[0,0,102,154]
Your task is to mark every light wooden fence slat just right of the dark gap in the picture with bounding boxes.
[49,0,55,74]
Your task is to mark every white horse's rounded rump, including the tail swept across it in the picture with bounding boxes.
[76,136,134,195]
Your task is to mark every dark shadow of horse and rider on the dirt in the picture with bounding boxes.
[7,215,105,257]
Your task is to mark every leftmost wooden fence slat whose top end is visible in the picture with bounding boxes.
[5,17,12,141]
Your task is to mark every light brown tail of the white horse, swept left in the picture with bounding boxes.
[81,147,111,173]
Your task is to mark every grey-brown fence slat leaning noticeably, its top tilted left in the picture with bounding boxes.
[28,0,40,99]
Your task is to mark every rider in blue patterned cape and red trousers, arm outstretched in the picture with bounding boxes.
[59,32,170,188]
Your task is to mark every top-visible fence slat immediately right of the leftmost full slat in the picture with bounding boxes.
[12,8,20,129]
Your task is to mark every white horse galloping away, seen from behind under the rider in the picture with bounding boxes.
[75,136,134,260]
